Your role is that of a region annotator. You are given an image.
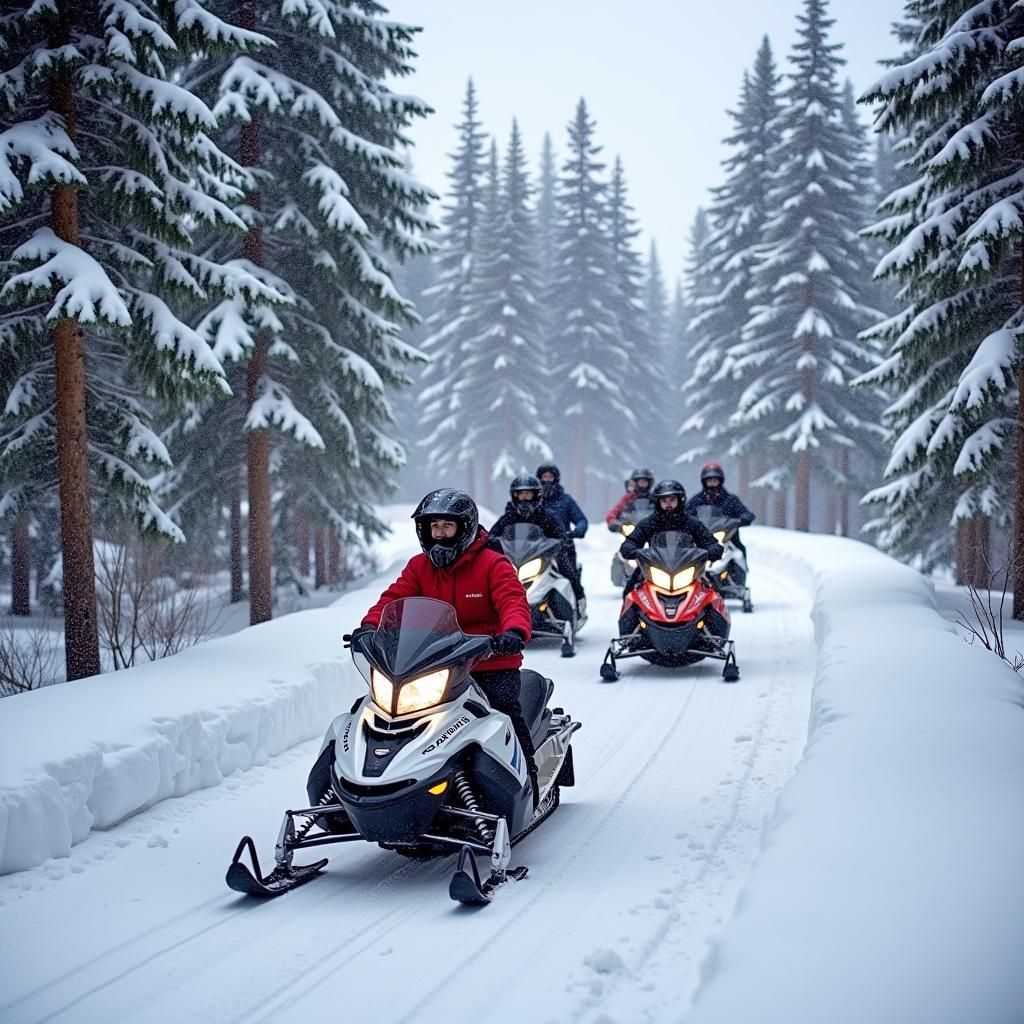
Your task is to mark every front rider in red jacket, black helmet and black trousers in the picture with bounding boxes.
[354,487,538,804]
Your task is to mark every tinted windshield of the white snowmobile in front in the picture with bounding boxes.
[366,597,490,682]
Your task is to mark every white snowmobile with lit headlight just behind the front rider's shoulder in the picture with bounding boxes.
[498,522,587,657]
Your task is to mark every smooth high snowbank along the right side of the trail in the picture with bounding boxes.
[685,529,1024,1024]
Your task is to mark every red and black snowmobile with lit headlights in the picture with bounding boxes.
[601,530,739,683]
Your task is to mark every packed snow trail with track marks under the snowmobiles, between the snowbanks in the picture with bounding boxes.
[0,536,815,1024]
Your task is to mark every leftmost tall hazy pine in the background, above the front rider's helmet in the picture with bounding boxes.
[418,79,486,494]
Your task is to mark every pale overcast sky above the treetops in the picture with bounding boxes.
[382,0,903,283]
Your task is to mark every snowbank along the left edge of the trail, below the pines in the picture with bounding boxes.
[0,509,412,874]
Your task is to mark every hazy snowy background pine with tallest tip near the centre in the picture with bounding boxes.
[547,99,637,503]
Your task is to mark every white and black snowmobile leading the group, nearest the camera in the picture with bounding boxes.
[226,597,581,905]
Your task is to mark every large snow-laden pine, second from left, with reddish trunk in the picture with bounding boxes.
[180,0,433,622]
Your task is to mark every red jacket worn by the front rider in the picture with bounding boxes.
[362,528,531,672]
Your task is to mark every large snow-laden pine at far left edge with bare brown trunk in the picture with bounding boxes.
[0,0,282,679]
